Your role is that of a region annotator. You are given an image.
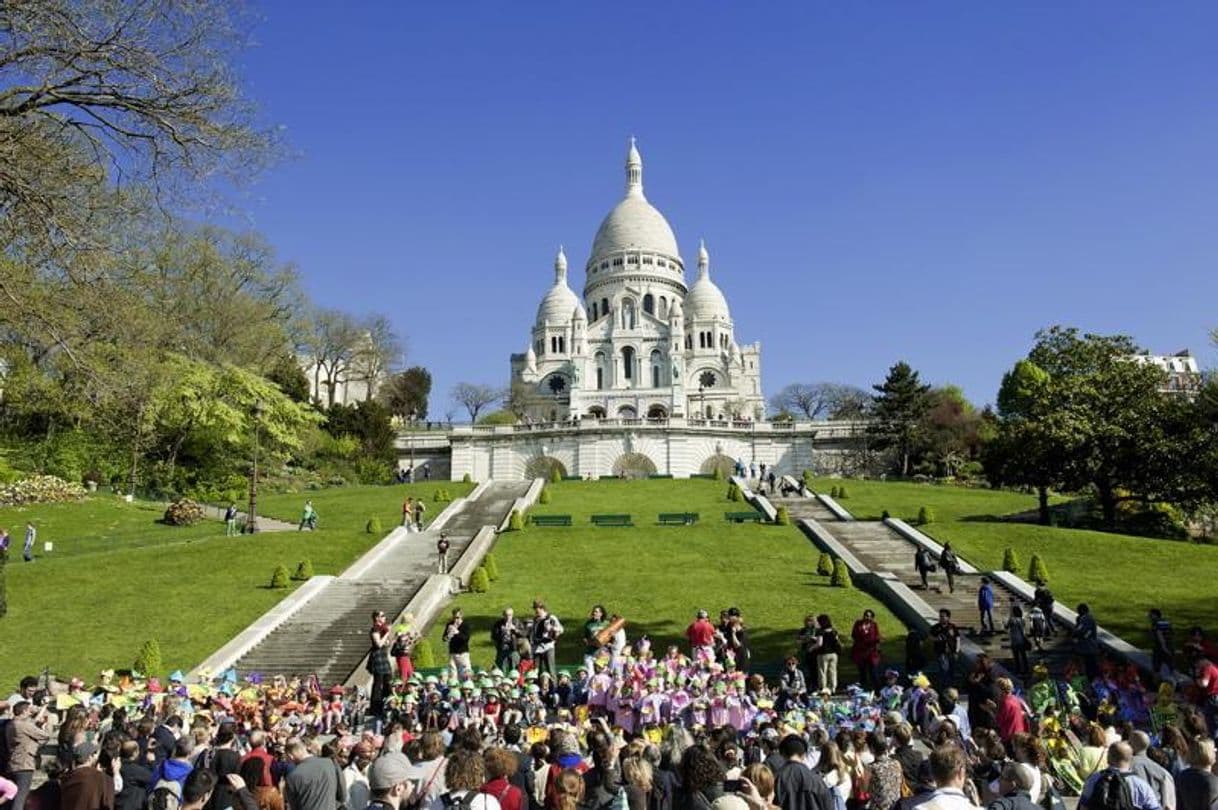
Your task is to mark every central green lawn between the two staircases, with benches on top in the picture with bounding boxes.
[430,480,904,676]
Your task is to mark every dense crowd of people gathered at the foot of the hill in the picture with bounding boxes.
[0,591,1218,810]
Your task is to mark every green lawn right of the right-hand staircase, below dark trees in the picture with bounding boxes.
[814,479,1218,647]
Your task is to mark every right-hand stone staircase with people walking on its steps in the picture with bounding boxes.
[773,496,1071,674]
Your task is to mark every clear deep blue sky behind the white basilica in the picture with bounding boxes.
[235,0,1218,417]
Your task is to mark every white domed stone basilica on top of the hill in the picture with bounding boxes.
[512,139,765,423]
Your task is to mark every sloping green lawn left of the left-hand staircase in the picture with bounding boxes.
[0,482,470,688]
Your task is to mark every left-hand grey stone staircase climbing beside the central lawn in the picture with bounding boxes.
[236,481,530,685]
